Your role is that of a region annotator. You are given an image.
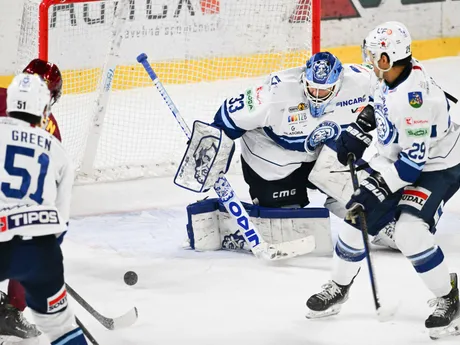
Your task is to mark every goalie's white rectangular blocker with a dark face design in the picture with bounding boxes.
[174,121,235,193]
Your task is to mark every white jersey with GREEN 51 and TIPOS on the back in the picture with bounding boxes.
[0,117,74,242]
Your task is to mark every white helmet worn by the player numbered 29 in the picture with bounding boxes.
[363,22,412,72]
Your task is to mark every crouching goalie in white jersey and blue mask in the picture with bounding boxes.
[179,52,384,252]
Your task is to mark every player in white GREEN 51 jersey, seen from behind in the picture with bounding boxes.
[0,74,87,345]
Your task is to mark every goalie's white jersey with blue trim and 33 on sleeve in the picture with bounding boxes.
[213,65,371,181]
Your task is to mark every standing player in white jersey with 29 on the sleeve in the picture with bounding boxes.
[307,22,460,338]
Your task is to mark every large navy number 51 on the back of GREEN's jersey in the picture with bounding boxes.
[1,145,50,205]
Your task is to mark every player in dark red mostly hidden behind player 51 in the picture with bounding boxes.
[0,59,62,338]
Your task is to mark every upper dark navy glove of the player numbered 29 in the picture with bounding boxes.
[336,105,376,165]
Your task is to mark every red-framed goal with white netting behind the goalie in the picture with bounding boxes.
[18,0,320,182]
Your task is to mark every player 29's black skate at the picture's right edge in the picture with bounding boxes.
[425,273,460,340]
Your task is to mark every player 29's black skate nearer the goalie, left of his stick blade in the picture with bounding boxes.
[305,280,352,319]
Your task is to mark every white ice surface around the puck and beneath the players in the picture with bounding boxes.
[3,58,460,345]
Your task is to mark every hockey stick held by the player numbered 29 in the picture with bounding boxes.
[348,153,396,322]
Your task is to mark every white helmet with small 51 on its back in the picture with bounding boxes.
[6,73,51,118]
